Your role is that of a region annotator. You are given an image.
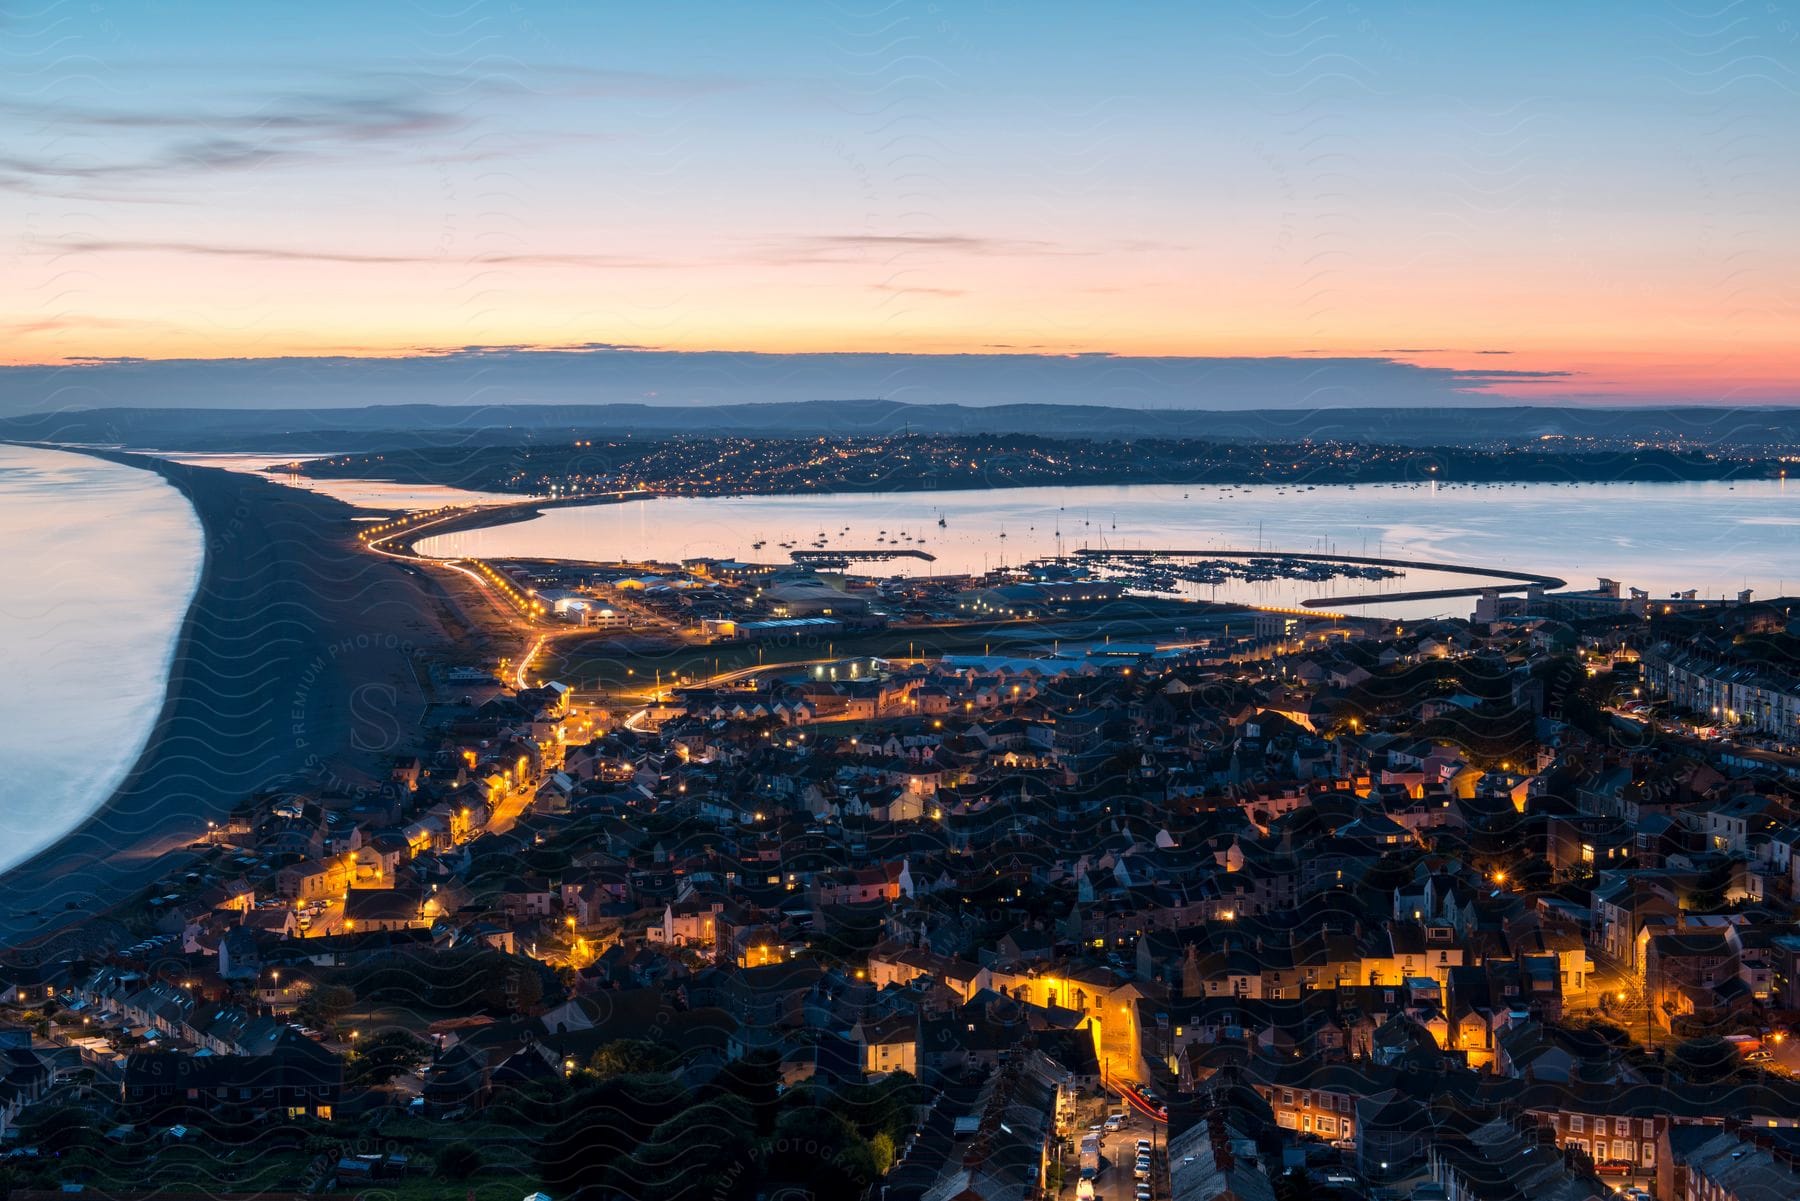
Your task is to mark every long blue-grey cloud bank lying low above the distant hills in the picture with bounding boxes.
[0,344,1568,414]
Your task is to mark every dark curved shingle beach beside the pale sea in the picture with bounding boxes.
[0,447,457,949]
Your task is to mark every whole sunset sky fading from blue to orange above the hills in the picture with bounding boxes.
[0,0,1800,409]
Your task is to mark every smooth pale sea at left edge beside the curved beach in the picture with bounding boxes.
[0,447,202,868]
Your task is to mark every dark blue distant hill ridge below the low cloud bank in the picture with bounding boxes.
[0,400,1800,452]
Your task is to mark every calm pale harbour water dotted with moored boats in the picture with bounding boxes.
[419,481,1800,618]
